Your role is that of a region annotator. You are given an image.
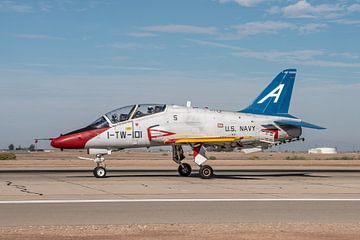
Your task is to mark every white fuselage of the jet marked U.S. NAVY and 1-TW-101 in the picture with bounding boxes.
[85,105,301,149]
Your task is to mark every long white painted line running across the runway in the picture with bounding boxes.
[0,198,360,204]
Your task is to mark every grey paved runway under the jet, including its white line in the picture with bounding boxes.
[0,168,360,226]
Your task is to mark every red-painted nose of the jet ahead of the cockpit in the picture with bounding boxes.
[50,128,107,149]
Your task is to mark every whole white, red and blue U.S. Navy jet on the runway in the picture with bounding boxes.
[51,69,324,178]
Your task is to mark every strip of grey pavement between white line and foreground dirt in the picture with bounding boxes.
[0,201,360,226]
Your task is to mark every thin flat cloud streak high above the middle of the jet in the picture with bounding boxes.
[143,24,217,34]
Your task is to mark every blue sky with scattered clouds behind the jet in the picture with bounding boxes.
[0,0,360,150]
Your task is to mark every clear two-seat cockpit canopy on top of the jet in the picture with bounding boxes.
[88,104,166,128]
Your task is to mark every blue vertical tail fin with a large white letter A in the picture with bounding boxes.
[240,69,296,117]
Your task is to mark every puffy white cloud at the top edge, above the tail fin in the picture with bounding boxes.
[280,0,344,18]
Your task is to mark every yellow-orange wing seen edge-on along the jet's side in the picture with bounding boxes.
[165,136,255,144]
